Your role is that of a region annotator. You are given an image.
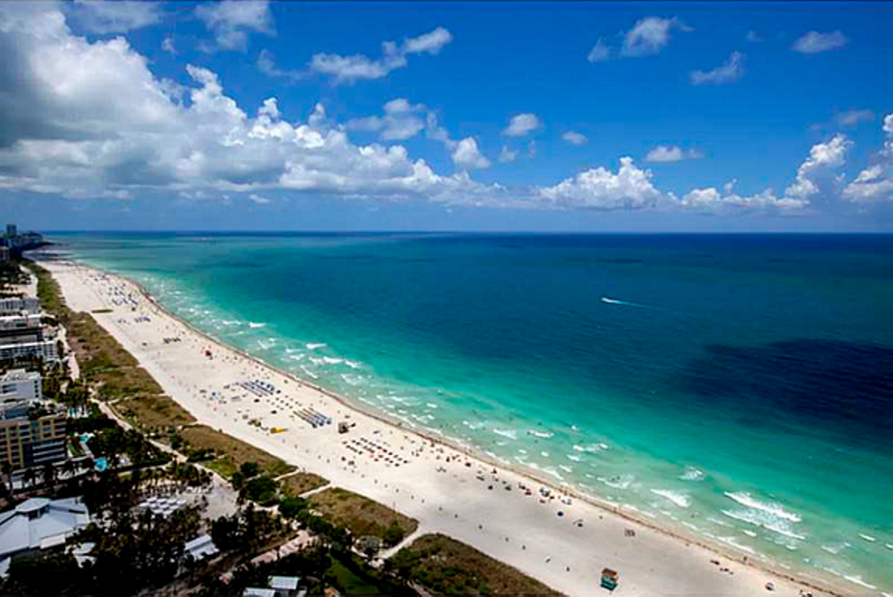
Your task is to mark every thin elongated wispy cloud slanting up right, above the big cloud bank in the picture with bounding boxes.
[309,27,453,84]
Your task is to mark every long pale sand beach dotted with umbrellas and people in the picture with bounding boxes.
[43,261,844,596]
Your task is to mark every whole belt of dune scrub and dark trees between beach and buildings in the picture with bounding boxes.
[6,265,555,597]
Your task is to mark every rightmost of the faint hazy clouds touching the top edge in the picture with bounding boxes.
[195,0,276,51]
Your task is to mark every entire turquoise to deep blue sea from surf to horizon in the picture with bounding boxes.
[53,234,893,591]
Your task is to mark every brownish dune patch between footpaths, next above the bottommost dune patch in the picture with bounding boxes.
[308,487,419,545]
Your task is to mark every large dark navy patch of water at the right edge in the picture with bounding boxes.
[676,339,893,445]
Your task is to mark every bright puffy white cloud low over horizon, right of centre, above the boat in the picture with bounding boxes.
[537,157,663,210]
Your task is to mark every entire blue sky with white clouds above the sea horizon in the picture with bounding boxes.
[0,1,893,231]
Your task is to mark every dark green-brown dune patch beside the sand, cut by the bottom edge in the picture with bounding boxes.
[386,534,560,595]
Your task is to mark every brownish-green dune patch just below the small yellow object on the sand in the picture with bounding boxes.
[179,425,295,479]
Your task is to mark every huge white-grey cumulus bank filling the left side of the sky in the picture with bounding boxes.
[0,4,500,203]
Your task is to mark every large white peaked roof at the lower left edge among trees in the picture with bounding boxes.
[0,498,90,557]
